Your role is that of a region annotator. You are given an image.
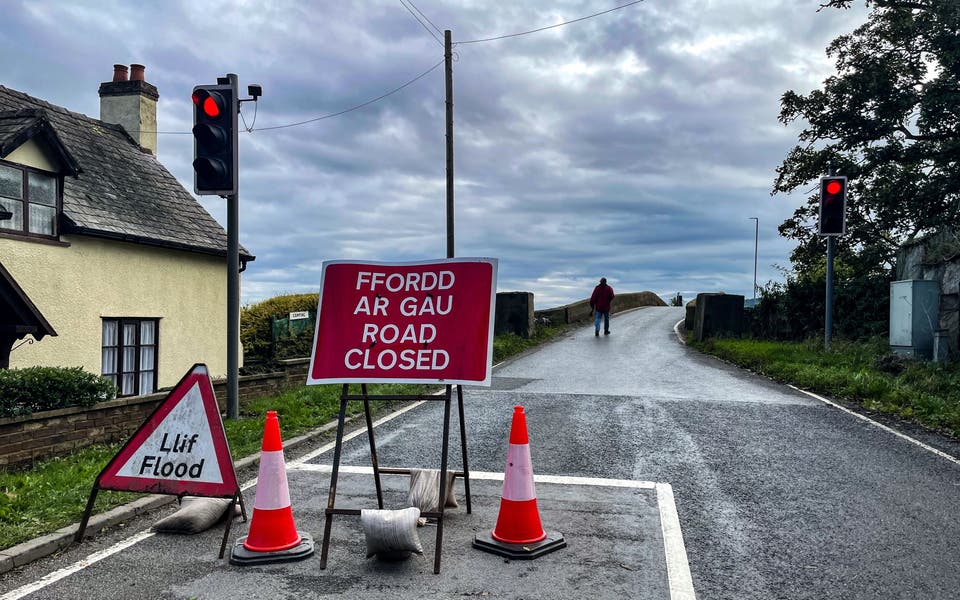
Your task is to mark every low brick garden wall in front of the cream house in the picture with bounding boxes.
[0,358,309,467]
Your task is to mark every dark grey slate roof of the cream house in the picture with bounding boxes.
[0,85,253,260]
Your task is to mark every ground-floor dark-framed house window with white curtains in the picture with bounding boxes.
[102,318,160,396]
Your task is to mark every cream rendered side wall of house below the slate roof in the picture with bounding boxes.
[0,230,236,387]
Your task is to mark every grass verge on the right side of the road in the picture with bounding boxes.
[689,339,960,438]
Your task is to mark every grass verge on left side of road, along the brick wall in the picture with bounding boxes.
[0,326,568,550]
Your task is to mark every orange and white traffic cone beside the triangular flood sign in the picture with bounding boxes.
[230,410,313,565]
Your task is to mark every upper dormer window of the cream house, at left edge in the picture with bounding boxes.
[0,163,60,237]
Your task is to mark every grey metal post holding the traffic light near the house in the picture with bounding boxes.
[227,73,240,419]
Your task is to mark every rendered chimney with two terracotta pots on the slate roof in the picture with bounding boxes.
[100,64,160,156]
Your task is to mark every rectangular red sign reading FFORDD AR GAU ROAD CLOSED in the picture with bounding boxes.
[307,258,497,385]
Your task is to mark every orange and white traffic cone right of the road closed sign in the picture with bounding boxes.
[473,406,567,559]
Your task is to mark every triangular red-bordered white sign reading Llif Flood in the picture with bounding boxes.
[97,364,239,498]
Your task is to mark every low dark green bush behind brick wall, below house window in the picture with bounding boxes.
[0,367,117,417]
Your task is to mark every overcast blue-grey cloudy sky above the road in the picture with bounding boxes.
[0,0,867,308]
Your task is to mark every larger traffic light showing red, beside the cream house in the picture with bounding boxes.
[192,85,237,196]
